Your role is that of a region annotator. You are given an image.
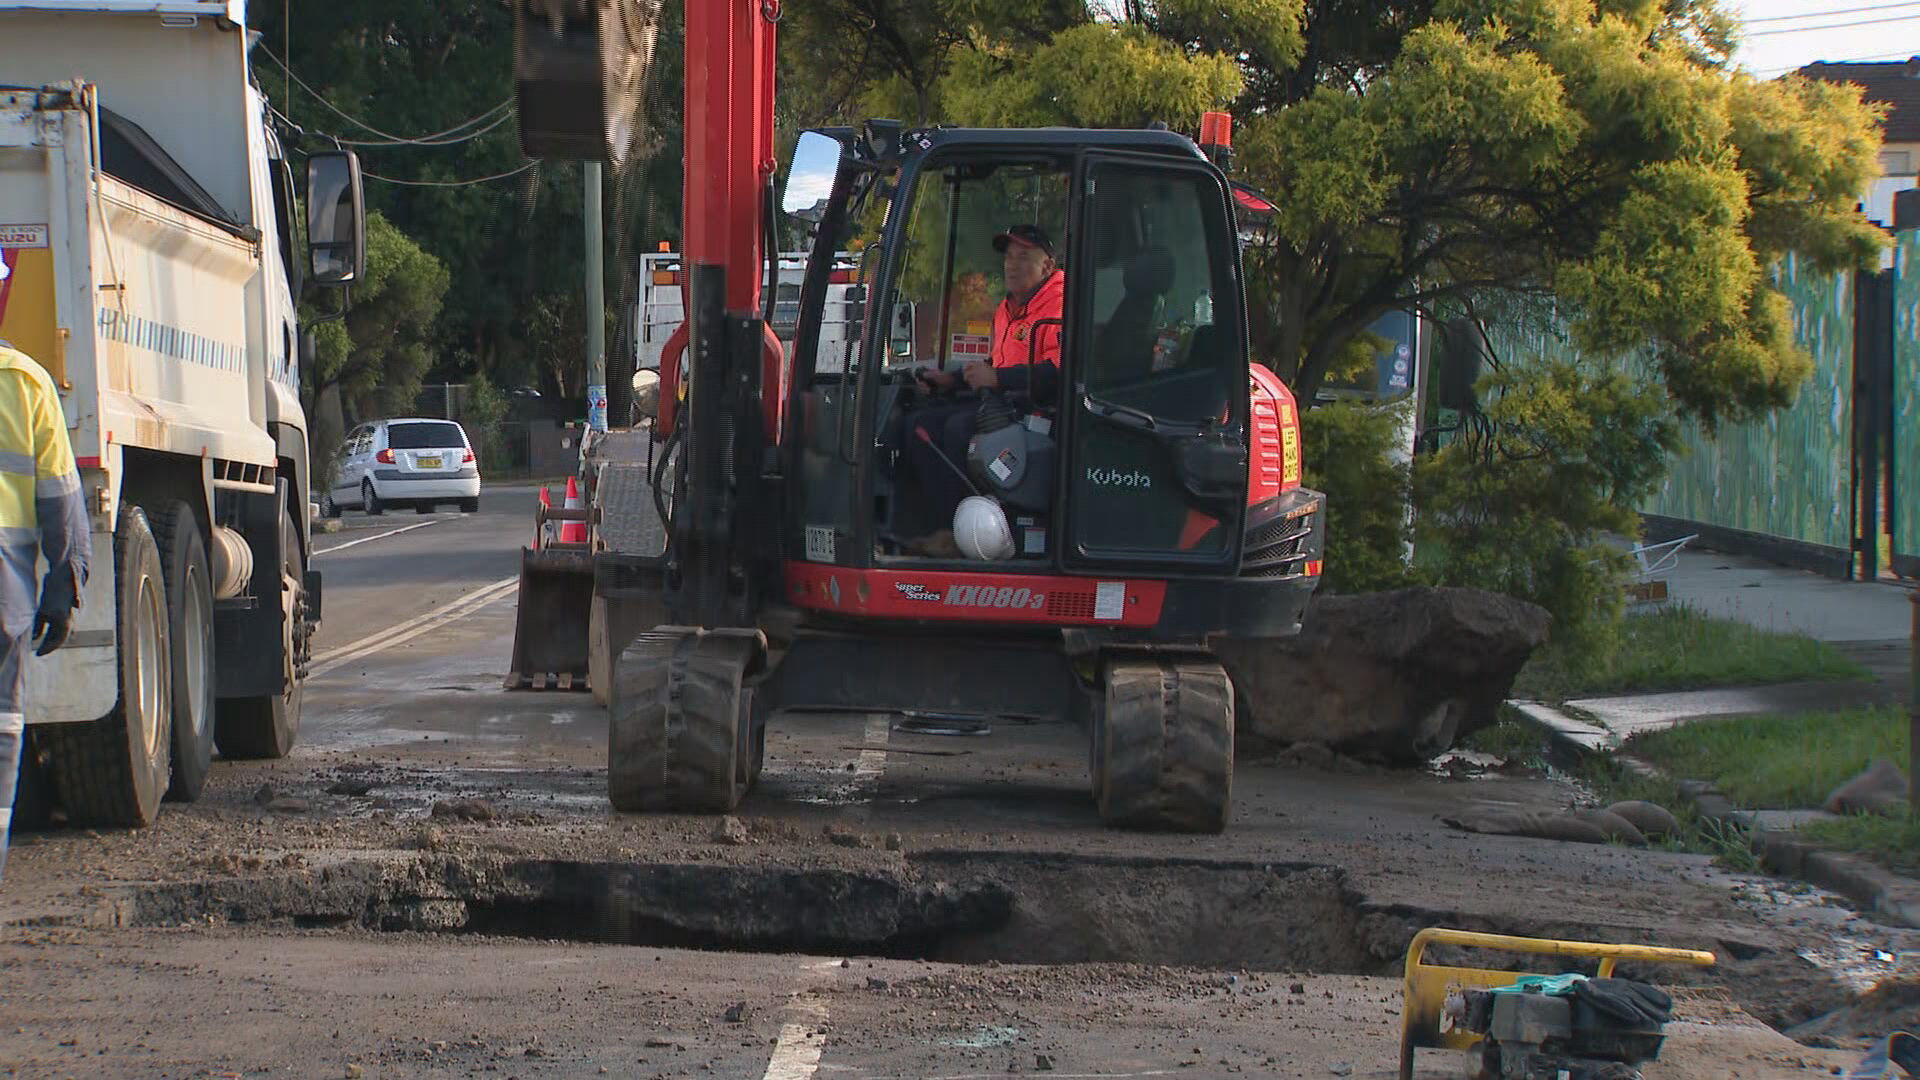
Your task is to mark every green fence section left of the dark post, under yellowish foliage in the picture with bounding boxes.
[1642,258,1853,550]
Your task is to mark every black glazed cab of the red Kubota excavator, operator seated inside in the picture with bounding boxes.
[787,123,1267,577]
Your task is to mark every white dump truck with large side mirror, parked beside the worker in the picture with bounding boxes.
[0,0,365,824]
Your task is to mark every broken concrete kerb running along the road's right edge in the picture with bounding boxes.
[1507,701,1920,928]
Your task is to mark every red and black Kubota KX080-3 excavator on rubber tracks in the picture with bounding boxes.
[515,0,1325,832]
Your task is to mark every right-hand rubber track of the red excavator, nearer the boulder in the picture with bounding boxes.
[1094,659,1233,832]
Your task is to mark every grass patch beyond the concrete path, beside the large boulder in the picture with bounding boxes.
[1513,607,1870,701]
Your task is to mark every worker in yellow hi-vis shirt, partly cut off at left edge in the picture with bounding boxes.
[0,342,88,878]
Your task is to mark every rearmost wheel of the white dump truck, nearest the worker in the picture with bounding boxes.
[40,505,173,826]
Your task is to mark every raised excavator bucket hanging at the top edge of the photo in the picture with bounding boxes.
[513,0,660,167]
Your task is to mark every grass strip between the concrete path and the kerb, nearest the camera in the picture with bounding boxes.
[1624,707,1907,809]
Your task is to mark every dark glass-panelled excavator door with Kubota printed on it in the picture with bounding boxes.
[1062,154,1248,573]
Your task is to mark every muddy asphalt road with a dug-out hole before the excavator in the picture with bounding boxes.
[0,488,1889,1080]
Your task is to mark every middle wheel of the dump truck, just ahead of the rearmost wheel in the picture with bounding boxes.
[154,502,213,803]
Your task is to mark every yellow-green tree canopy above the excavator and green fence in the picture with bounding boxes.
[771,0,1882,423]
